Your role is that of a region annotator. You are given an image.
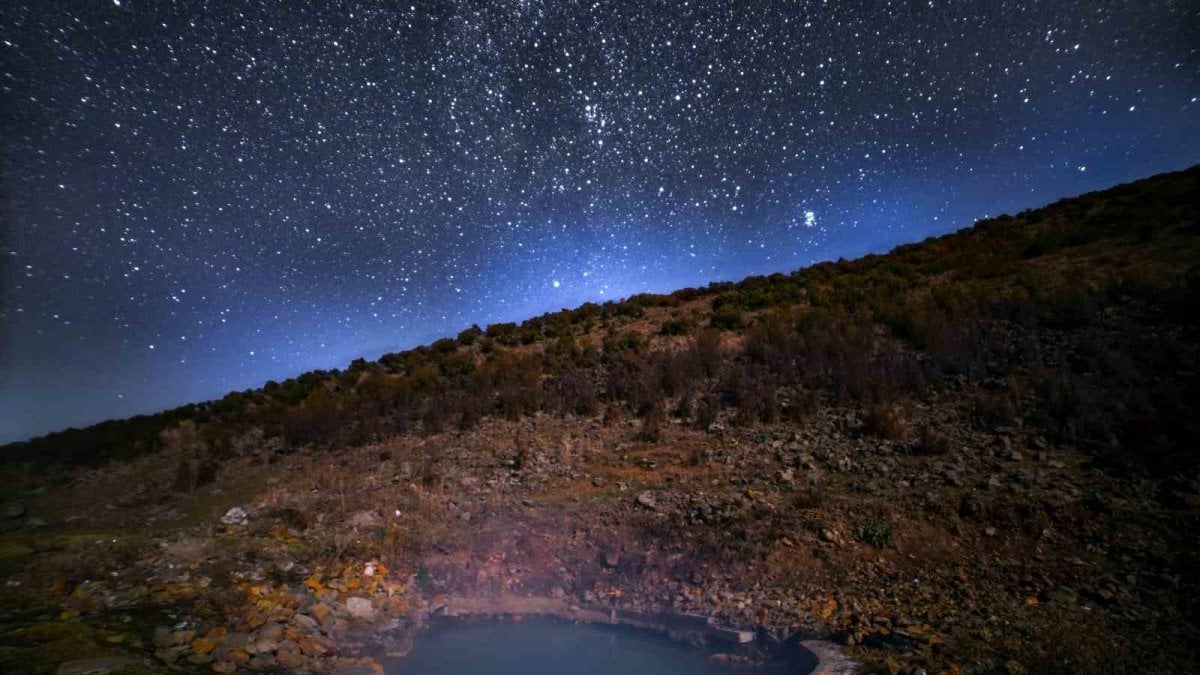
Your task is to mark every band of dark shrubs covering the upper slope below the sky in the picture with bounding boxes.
[0,168,1200,474]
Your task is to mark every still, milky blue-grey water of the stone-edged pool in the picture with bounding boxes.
[384,619,808,675]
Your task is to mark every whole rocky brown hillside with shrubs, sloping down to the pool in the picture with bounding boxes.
[0,167,1200,673]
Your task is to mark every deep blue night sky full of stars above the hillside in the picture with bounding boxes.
[0,0,1200,441]
